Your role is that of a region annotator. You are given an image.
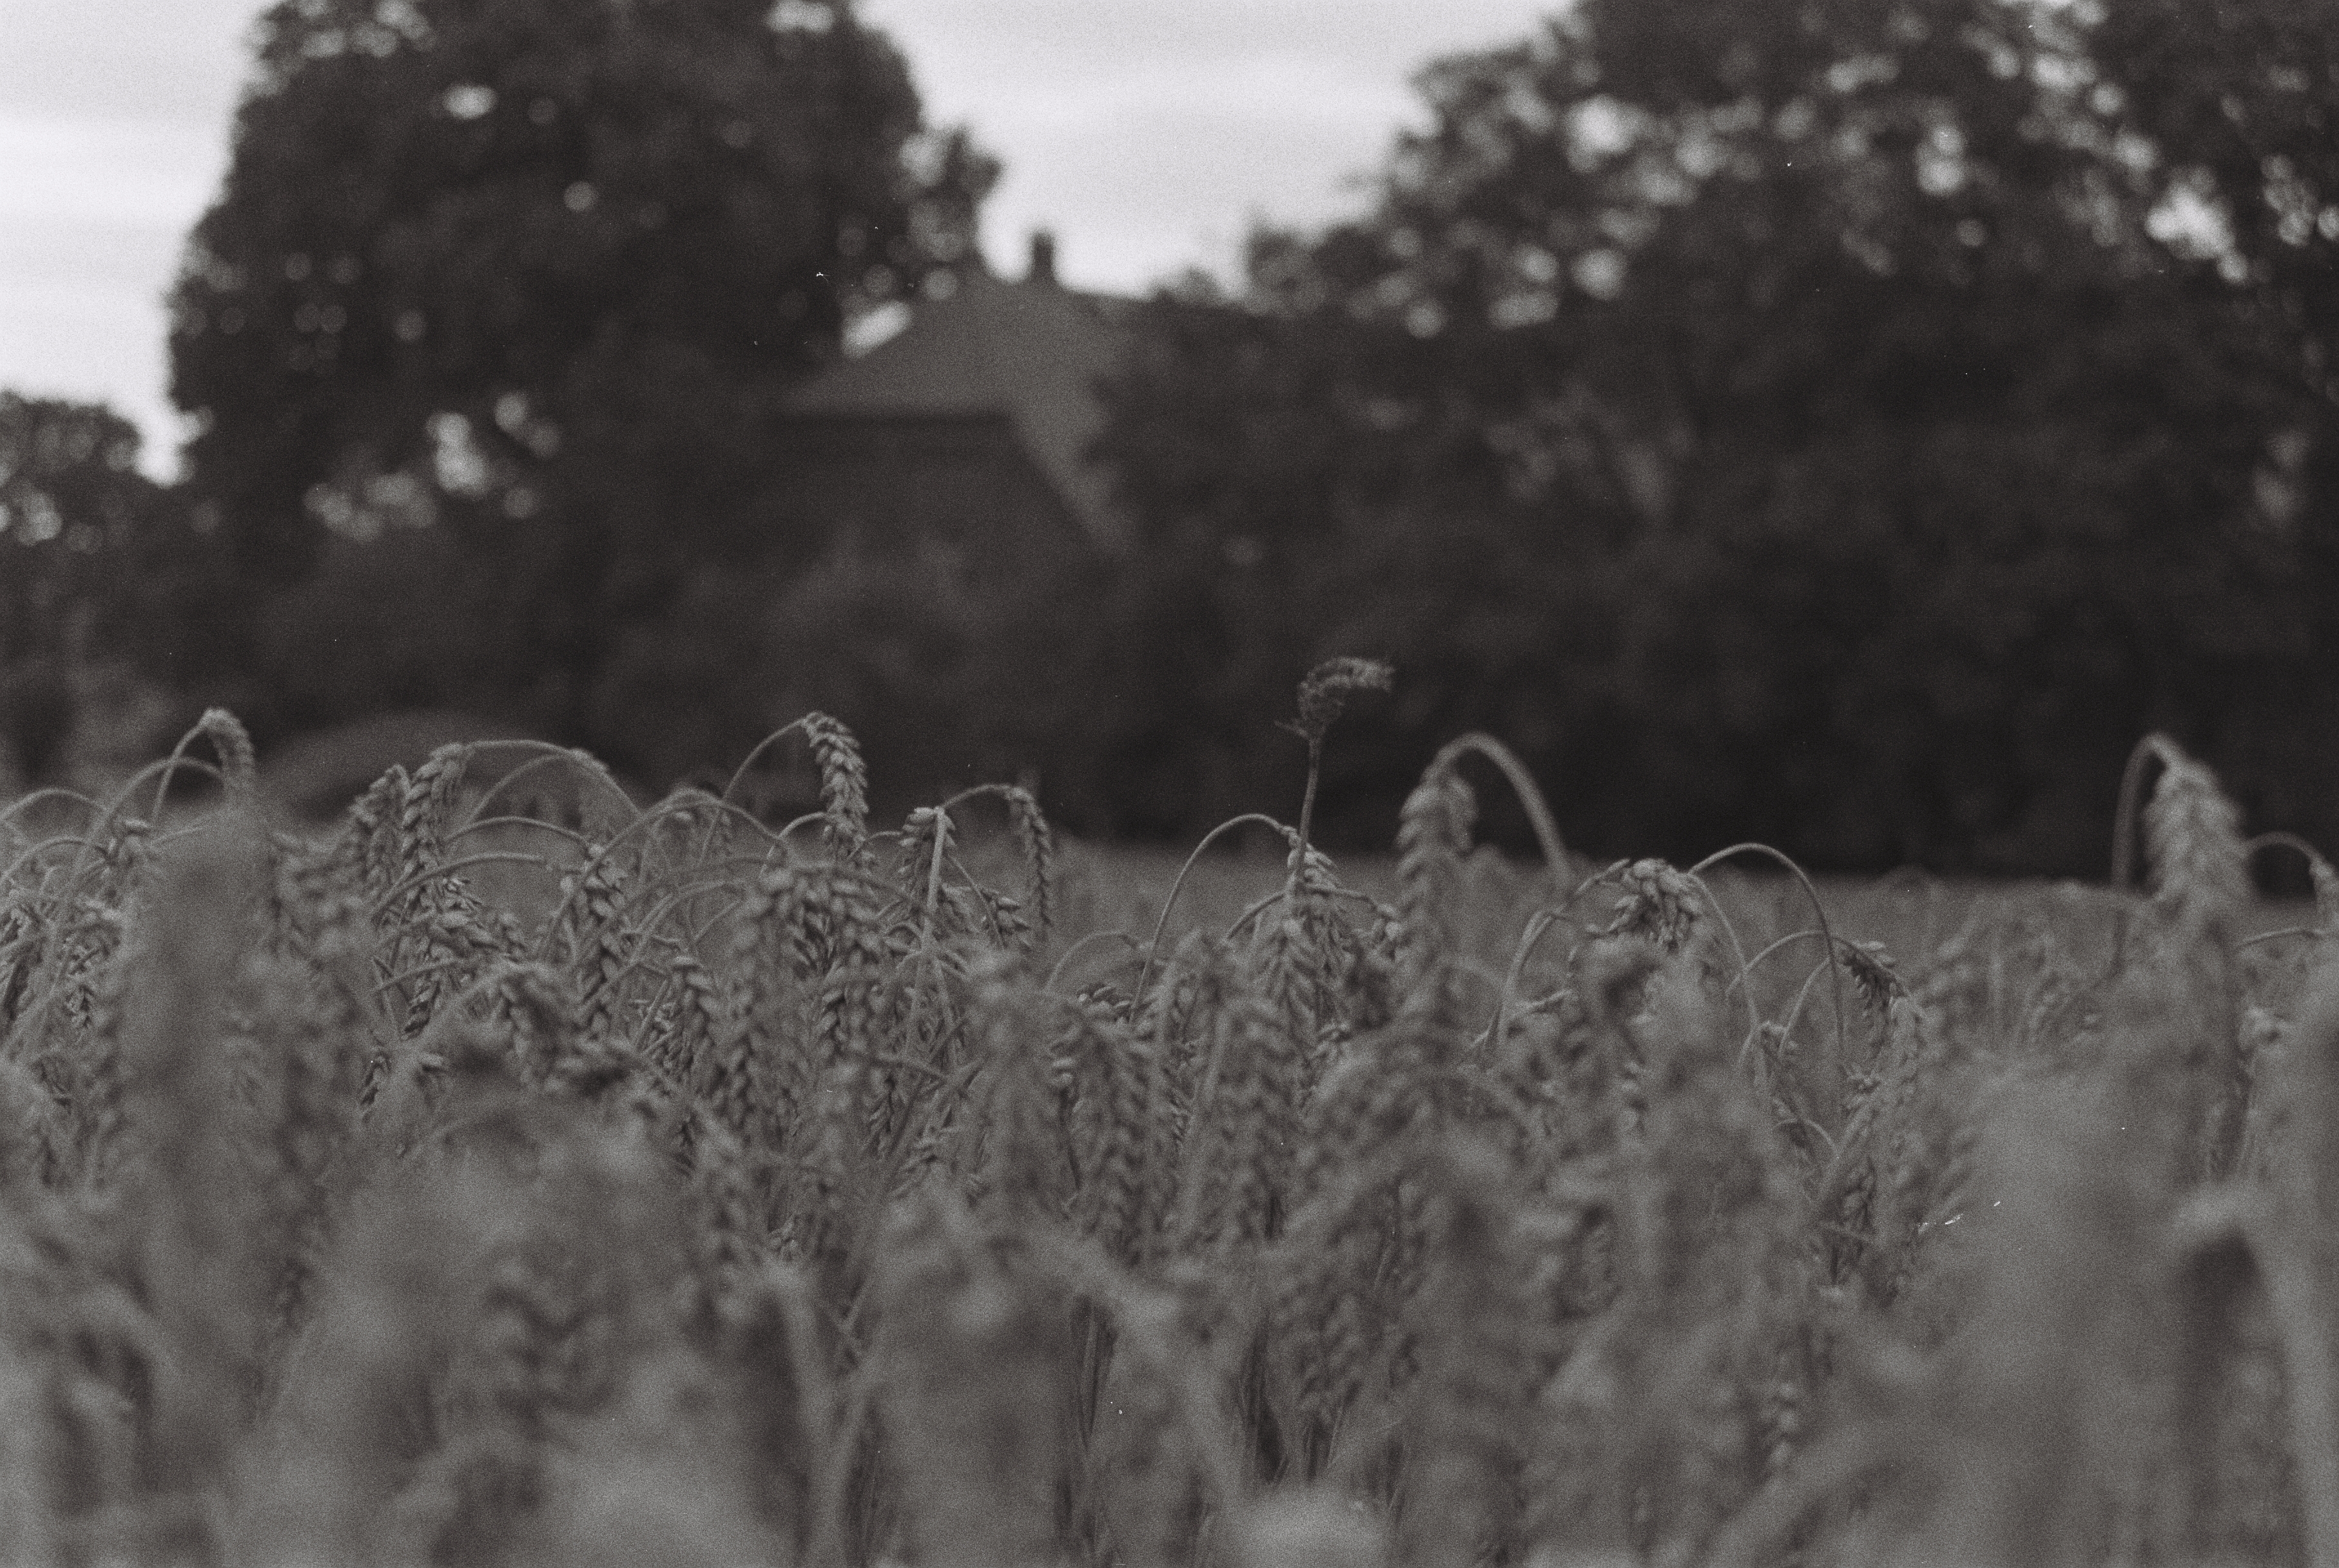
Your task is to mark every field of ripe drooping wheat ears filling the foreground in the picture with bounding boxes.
[0,679,2339,1568]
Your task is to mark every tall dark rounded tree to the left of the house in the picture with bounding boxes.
[171,0,994,759]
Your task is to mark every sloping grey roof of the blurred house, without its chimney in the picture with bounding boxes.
[788,257,1130,545]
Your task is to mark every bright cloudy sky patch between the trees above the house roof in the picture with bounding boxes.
[863,0,1555,293]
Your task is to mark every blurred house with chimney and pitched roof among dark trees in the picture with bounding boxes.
[788,234,1132,568]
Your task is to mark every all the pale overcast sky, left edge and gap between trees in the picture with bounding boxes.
[0,0,1551,478]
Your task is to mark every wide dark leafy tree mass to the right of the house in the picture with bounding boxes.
[1109,0,2329,868]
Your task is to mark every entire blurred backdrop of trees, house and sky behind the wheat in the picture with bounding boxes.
[0,0,2339,873]
